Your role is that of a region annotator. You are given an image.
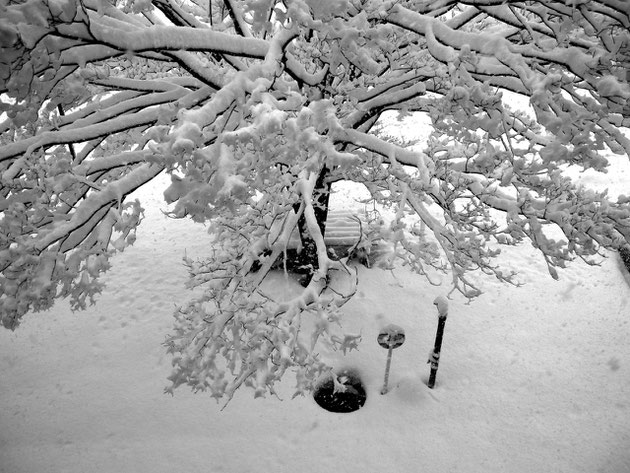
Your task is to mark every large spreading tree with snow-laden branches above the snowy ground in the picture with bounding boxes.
[0,0,630,398]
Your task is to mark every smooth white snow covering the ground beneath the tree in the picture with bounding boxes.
[0,153,630,473]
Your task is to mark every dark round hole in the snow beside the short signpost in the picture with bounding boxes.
[313,369,366,412]
